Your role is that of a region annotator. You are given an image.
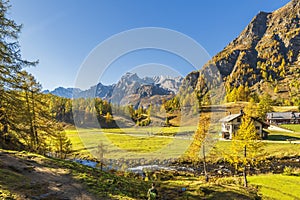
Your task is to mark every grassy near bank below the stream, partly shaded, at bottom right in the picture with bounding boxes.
[162,174,300,200]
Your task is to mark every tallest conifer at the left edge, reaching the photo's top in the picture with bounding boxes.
[0,0,36,147]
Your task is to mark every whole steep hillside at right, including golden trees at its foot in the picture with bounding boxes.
[186,0,300,105]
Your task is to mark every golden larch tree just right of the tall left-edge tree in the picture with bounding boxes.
[14,71,71,157]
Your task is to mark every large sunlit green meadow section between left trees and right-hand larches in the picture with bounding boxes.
[66,128,191,160]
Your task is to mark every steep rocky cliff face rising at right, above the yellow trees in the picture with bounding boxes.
[184,0,300,97]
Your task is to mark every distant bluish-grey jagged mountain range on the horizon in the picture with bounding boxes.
[44,72,183,104]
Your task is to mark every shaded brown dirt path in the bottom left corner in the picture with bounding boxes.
[0,151,97,200]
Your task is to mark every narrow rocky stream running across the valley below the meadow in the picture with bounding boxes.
[72,156,300,176]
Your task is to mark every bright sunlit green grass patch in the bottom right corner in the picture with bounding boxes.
[249,174,300,200]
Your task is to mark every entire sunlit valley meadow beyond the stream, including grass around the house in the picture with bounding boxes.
[66,125,300,159]
